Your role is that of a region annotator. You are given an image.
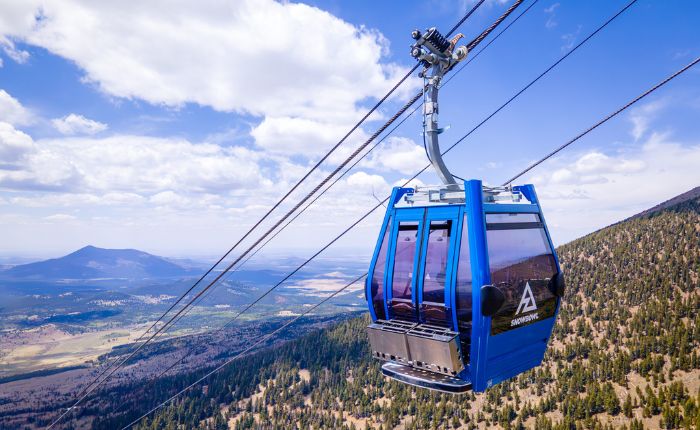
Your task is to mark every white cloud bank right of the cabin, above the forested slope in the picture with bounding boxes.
[523,133,700,243]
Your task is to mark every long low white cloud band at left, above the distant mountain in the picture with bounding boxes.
[0,134,269,198]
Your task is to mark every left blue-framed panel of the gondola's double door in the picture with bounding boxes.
[385,208,425,322]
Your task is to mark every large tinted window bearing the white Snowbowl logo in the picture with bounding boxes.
[486,214,557,334]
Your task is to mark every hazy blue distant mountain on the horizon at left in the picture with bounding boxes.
[0,246,192,279]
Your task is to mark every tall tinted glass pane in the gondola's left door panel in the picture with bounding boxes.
[391,221,418,317]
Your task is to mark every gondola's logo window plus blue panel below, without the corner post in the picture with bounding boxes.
[485,209,559,385]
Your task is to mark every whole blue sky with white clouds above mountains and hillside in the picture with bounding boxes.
[0,0,700,256]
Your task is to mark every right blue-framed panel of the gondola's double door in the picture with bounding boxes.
[418,206,459,329]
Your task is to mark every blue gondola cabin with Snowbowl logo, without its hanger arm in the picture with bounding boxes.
[365,180,564,393]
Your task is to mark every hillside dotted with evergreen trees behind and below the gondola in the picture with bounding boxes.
[93,198,700,429]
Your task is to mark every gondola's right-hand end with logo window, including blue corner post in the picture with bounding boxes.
[466,181,560,391]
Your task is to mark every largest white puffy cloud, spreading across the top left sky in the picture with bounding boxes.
[0,0,419,158]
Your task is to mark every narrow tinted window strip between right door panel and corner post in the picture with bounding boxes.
[456,217,472,363]
